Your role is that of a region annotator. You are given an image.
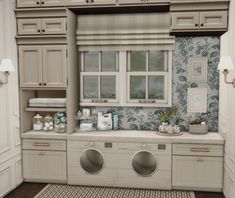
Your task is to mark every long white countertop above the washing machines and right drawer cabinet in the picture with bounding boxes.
[67,130,224,144]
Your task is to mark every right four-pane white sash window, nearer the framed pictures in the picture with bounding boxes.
[127,50,171,103]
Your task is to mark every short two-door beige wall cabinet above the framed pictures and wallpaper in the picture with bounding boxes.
[171,11,228,31]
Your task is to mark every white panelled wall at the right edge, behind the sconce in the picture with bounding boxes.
[219,0,235,198]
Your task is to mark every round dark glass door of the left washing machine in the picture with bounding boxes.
[80,149,104,174]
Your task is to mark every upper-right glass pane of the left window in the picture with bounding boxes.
[101,52,116,72]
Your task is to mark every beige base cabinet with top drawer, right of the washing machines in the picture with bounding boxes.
[172,144,223,191]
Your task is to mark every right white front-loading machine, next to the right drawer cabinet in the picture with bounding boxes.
[118,143,171,189]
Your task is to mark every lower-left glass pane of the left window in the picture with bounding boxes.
[83,76,99,99]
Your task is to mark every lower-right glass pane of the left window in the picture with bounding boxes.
[100,76,116,99]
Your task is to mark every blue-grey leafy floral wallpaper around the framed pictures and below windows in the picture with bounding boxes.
[87,37,220,132]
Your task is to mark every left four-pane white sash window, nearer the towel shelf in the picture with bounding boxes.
[80,51,119,103]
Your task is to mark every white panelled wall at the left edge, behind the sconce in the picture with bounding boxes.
[0,0,22,197]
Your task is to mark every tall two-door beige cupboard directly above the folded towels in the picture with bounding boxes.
[19,45,67,87]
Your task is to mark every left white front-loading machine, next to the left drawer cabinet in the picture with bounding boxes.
[68,141,117,186]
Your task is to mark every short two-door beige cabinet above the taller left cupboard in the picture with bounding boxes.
[17,18,66,35]
